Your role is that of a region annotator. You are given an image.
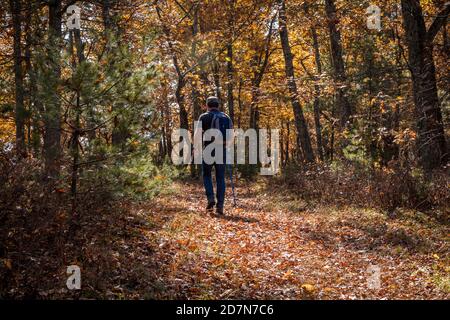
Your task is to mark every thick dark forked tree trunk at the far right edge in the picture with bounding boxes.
[401,0,450,172]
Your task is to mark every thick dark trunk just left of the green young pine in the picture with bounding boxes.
[44,0,62,178]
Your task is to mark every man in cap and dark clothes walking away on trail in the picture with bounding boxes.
[198,97,233,215]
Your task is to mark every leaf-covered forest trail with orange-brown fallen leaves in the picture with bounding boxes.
[140,182,450,299]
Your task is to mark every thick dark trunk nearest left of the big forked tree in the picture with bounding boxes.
[325,0,352,130]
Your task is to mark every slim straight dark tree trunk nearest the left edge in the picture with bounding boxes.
[10,0,26,157]
